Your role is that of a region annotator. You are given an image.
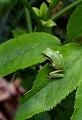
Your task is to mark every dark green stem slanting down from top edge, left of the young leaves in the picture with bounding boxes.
[22,0,42,26]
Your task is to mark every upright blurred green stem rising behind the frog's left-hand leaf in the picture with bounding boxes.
[25,7,32,33]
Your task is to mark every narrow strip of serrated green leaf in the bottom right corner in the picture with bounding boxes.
[71,81,82,120]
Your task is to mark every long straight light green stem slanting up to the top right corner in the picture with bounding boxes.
[51,0,82,20]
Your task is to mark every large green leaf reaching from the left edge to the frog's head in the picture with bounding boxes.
[0,33,60,76]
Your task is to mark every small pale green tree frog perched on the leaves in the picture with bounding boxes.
[42,48,64,78]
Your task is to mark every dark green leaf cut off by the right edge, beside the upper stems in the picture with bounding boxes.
[67,5,82,40]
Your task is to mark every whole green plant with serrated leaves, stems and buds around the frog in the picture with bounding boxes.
[0,0,82,120]
